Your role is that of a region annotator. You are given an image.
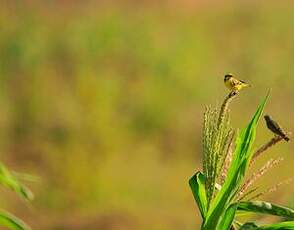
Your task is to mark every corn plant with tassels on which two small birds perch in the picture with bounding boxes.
[189,93,294,230]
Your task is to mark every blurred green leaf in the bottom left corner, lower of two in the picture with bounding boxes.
[0,211,30,230]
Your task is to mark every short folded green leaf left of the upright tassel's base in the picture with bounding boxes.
[189,172,207,219]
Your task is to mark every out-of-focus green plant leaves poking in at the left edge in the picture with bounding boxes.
[0,163,33,230]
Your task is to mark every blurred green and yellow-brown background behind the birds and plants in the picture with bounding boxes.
[0,0,294,230]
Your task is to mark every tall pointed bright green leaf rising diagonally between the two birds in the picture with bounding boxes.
[203,94,269,230]
